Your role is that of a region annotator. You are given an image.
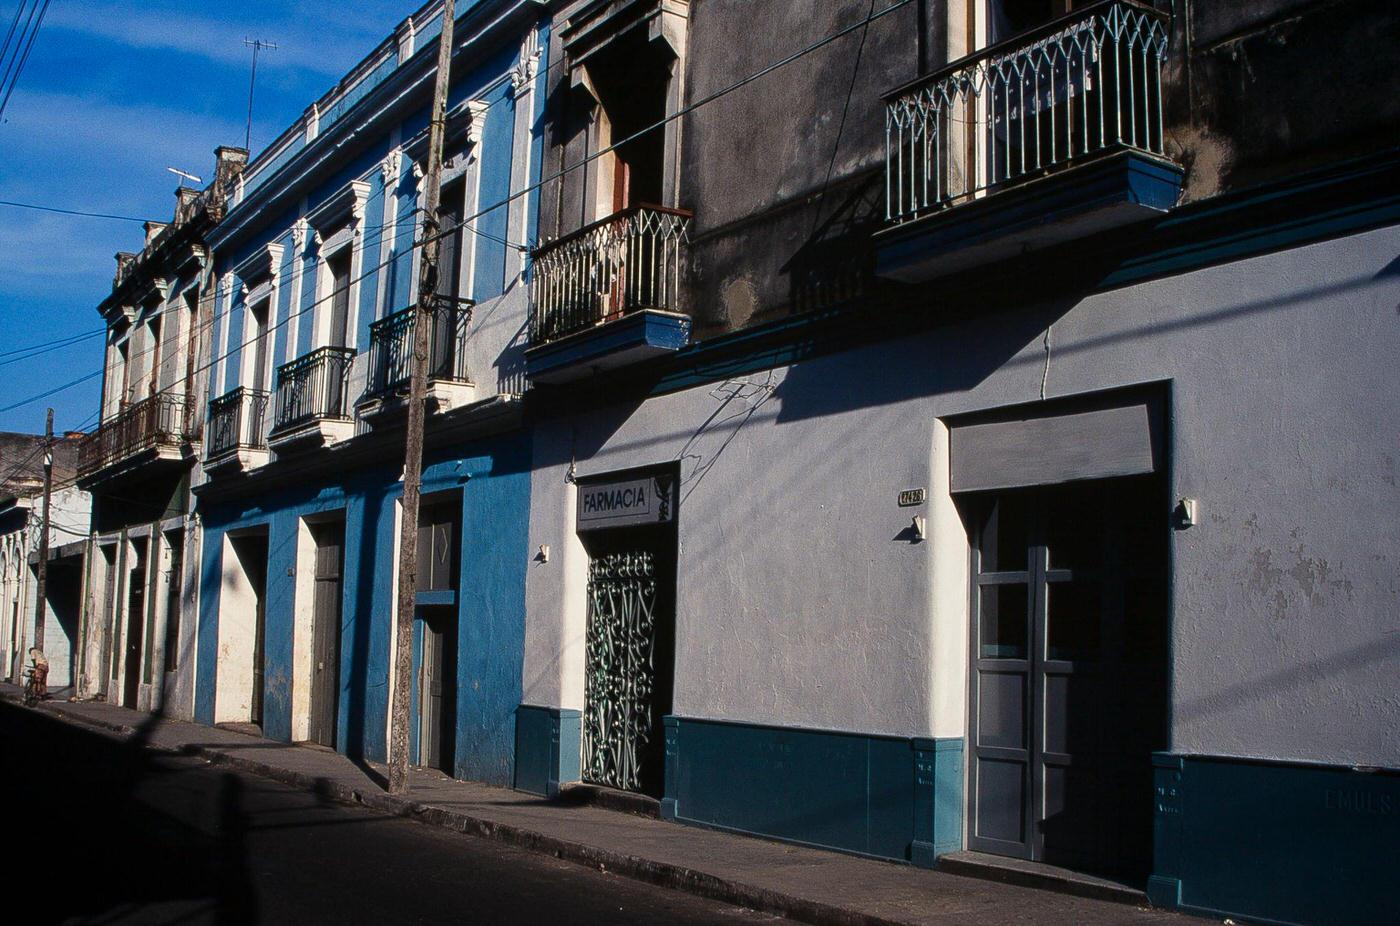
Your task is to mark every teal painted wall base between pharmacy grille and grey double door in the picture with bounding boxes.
[661,717,963,866]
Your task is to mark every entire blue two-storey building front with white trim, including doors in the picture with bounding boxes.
[195,0,549,785]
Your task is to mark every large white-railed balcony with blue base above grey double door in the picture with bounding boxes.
[876,0,1182,283]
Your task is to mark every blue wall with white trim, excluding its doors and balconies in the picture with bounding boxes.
[195,0,549,785]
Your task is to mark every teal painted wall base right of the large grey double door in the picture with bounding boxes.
[1148,755,1400,926]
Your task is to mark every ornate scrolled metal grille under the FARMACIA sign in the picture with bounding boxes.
[584,551,657,790]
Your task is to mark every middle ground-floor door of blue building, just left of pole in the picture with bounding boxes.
[309,521,346,748]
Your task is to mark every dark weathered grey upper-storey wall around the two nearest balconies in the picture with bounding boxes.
[540,0,1400,338]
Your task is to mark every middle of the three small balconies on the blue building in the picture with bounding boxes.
[267,347,354,454]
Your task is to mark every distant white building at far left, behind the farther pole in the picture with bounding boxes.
[0,434,91,688]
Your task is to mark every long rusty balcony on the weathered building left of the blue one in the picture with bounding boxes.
[78,394,199,485]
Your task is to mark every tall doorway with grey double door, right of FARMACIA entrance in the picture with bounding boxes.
[967,476,1168,881]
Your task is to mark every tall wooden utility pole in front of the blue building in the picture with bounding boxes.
[389,0,456,794]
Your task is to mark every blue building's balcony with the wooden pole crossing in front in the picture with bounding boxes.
[356,300,476,424]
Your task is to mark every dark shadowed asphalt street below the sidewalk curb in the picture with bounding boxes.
[0,703,780,926]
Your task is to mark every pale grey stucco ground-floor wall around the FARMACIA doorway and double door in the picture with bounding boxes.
[524,227,1400,768]
